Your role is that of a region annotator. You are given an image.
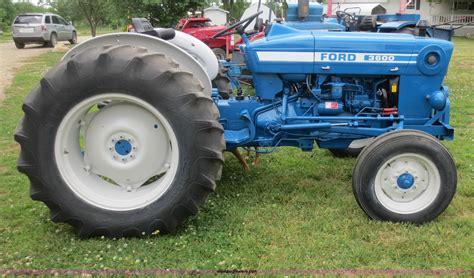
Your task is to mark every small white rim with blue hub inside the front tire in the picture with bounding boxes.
[375,153,441,214]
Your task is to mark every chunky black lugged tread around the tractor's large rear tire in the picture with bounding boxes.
[15,46,225,237]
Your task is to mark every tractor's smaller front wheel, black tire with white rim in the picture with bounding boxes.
[352,130,457,223]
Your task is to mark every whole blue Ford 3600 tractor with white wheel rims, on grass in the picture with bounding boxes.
[15,6,457,237]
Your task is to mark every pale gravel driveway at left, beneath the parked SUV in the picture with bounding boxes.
[0,36,89,101]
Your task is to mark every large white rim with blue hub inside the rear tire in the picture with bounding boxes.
[54,93,179,211]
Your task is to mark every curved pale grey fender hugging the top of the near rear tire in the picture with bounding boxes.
[62,33,213,96]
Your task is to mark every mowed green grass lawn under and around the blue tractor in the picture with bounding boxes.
[0,39,474,270]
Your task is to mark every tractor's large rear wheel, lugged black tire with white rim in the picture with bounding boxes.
[15,46,225,238]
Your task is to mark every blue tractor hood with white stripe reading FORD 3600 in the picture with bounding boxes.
[243,24,453,75]
